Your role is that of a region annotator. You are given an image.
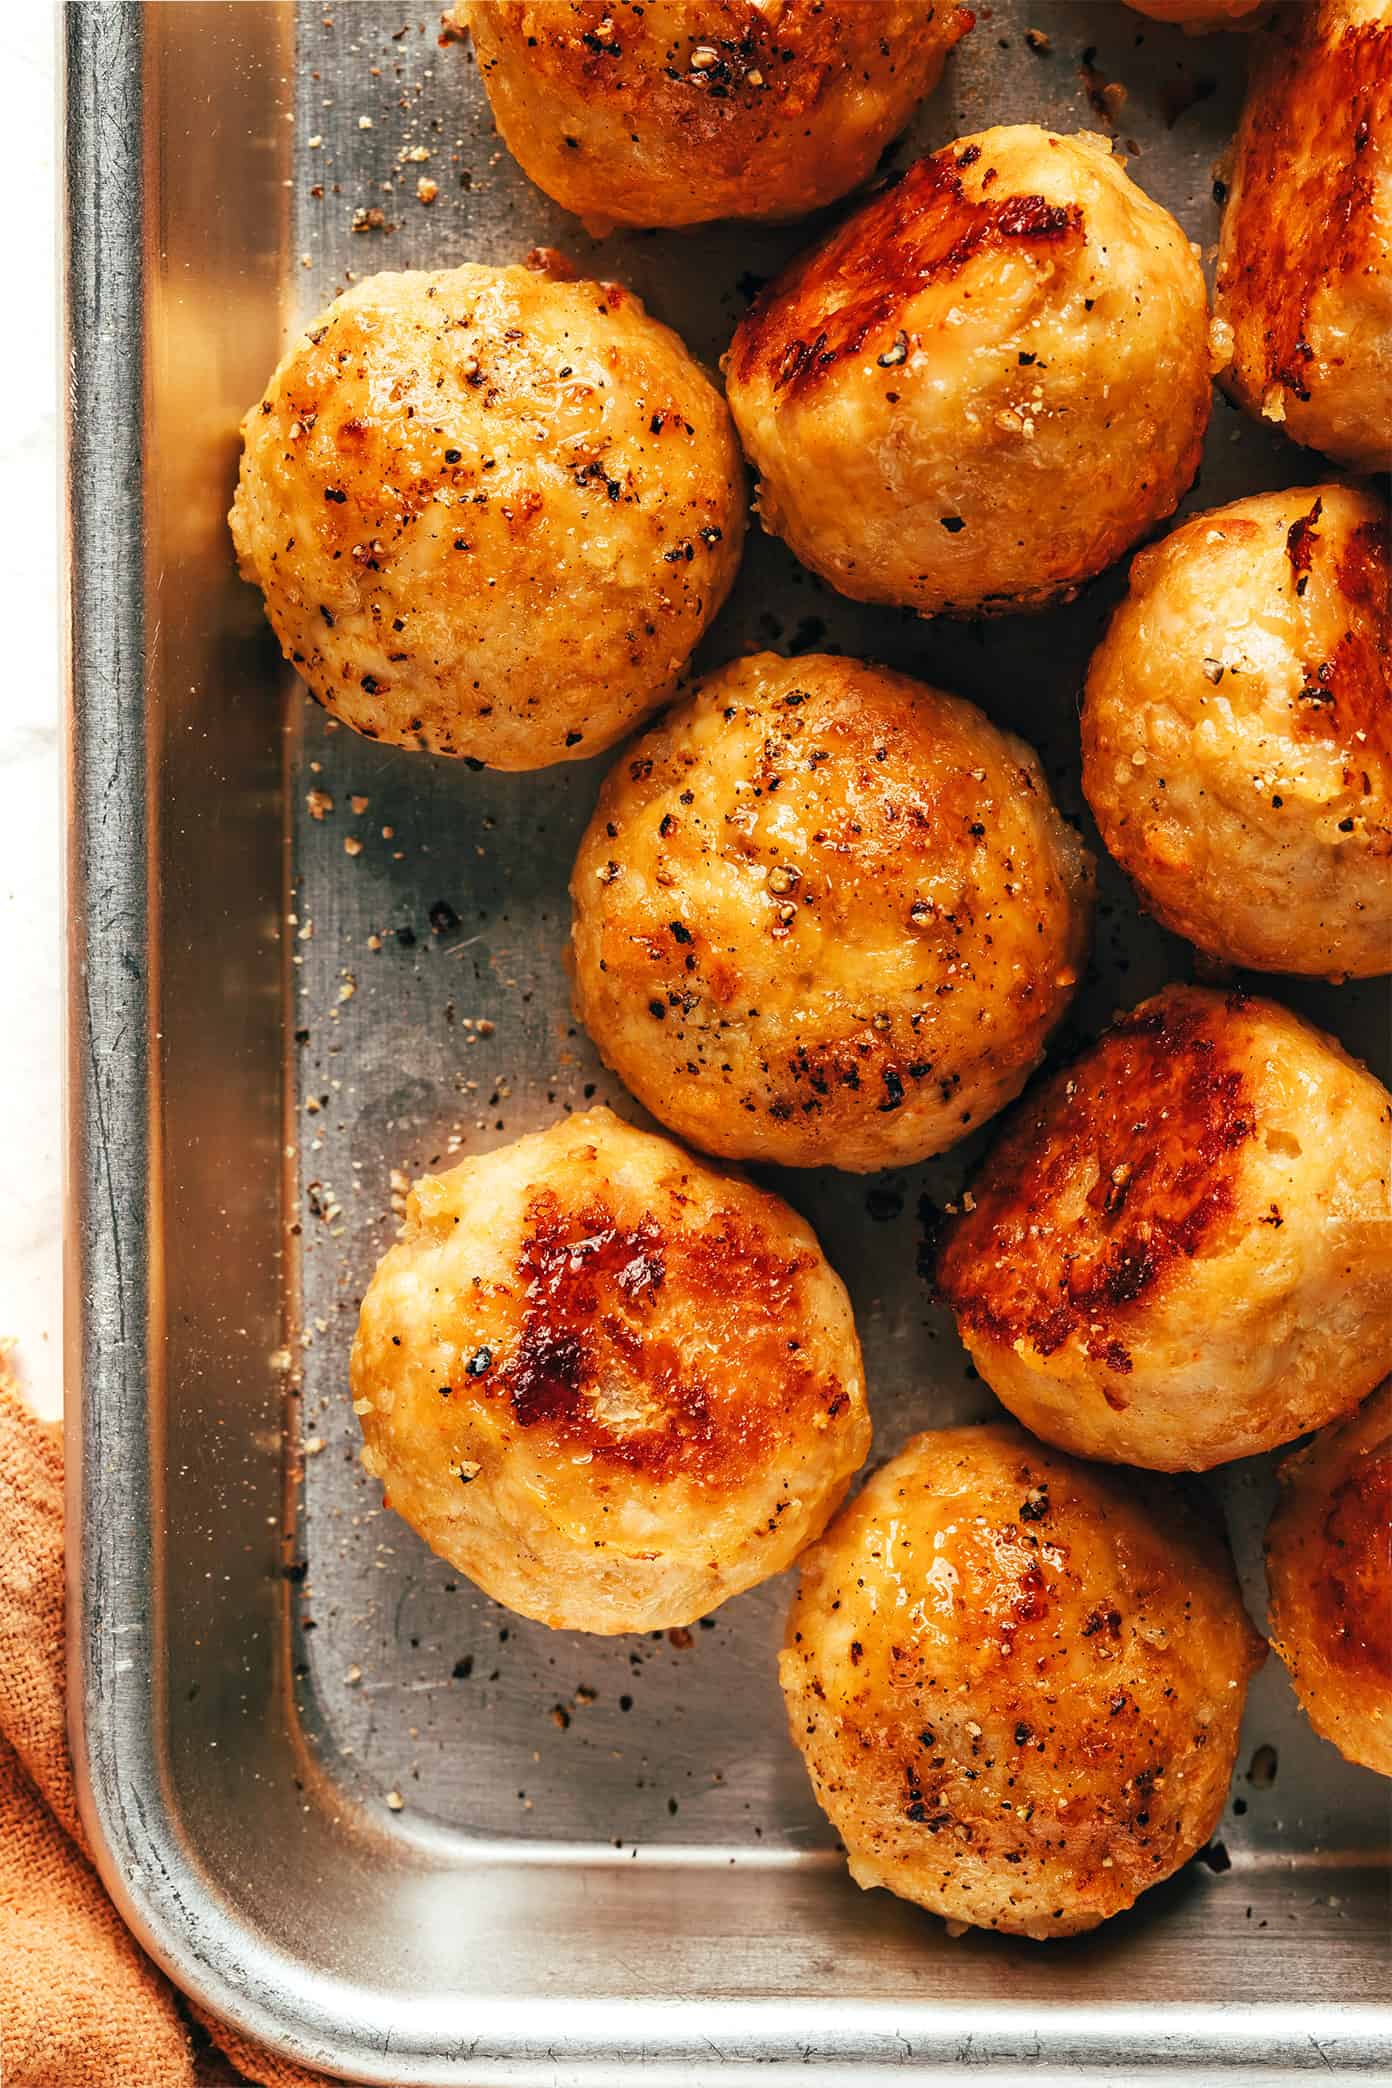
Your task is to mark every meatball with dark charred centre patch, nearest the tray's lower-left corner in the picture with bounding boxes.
[351,1109,870,1633]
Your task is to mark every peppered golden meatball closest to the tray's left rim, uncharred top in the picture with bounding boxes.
[232,265,745,768]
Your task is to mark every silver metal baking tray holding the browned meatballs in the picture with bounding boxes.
[65,0,1392,2088]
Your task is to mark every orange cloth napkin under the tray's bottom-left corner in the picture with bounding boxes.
[0,1349,356,2088]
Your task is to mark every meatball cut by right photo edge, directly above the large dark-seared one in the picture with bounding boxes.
[1083,487,1392,979]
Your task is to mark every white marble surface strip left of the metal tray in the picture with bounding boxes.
[0,12,63,1414]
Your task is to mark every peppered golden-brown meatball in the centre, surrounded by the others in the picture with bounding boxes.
[570,654,1091,1169]
